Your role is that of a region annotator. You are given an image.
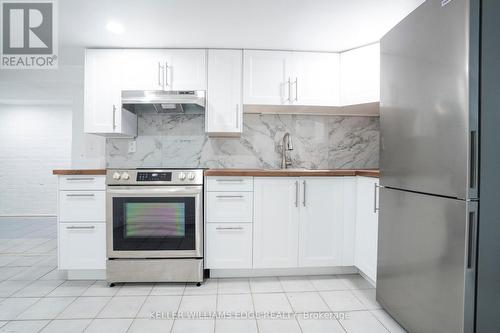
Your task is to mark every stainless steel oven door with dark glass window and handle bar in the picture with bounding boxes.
[106,186,203,258]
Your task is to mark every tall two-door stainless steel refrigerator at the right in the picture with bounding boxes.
[377,0,500,333]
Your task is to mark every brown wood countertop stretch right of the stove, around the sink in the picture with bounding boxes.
[205,169,379,178]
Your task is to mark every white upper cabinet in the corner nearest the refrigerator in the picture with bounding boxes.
[340,44,380,105]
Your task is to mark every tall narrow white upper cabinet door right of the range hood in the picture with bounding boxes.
[206,50,243,135]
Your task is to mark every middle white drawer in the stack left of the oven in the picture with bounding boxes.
[59,191,106,222]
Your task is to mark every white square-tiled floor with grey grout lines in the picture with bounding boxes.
[0,218,405,333]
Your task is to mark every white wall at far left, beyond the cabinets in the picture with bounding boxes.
[0,104,72,216]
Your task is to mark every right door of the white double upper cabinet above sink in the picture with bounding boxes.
[292,52,340,106]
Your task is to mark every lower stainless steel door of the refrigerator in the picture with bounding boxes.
[377,188,476,333]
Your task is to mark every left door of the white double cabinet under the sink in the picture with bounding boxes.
[253,177,299,268]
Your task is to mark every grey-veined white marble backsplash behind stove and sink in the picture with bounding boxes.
[106,114,379,169]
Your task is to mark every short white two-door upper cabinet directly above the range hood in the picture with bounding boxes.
[122,49,207,90]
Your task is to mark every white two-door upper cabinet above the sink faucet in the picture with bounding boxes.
[243,50,339,106]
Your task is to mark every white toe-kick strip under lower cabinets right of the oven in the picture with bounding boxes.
[210,266,358,278]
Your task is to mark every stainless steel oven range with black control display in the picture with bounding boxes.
[106,169,203,286]
